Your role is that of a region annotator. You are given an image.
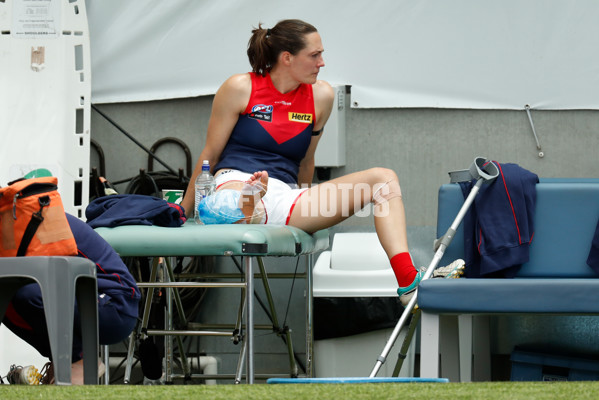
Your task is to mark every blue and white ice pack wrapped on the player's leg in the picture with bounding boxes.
[198,189,244,225]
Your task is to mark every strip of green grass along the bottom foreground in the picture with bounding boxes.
[0,382,599,400]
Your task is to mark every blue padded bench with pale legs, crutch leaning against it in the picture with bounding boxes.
[418,178,599,381]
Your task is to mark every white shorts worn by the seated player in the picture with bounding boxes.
[214,169,308,225]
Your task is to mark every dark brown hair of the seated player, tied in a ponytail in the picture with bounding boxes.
[247,19,317,76]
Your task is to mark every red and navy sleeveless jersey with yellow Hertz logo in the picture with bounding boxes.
[214,73,315,184]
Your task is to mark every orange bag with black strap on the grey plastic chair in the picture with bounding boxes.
[0,177,77,257]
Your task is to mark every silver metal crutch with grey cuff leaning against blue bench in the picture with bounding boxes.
[370,157,499,378]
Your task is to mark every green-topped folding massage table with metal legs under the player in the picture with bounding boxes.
[95,222,329,384]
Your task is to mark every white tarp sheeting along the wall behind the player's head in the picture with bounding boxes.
[87,0,599,109]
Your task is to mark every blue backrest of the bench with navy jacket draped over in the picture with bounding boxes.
[437,179,599,278]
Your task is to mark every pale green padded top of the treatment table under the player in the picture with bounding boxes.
[95,222,329,257]
